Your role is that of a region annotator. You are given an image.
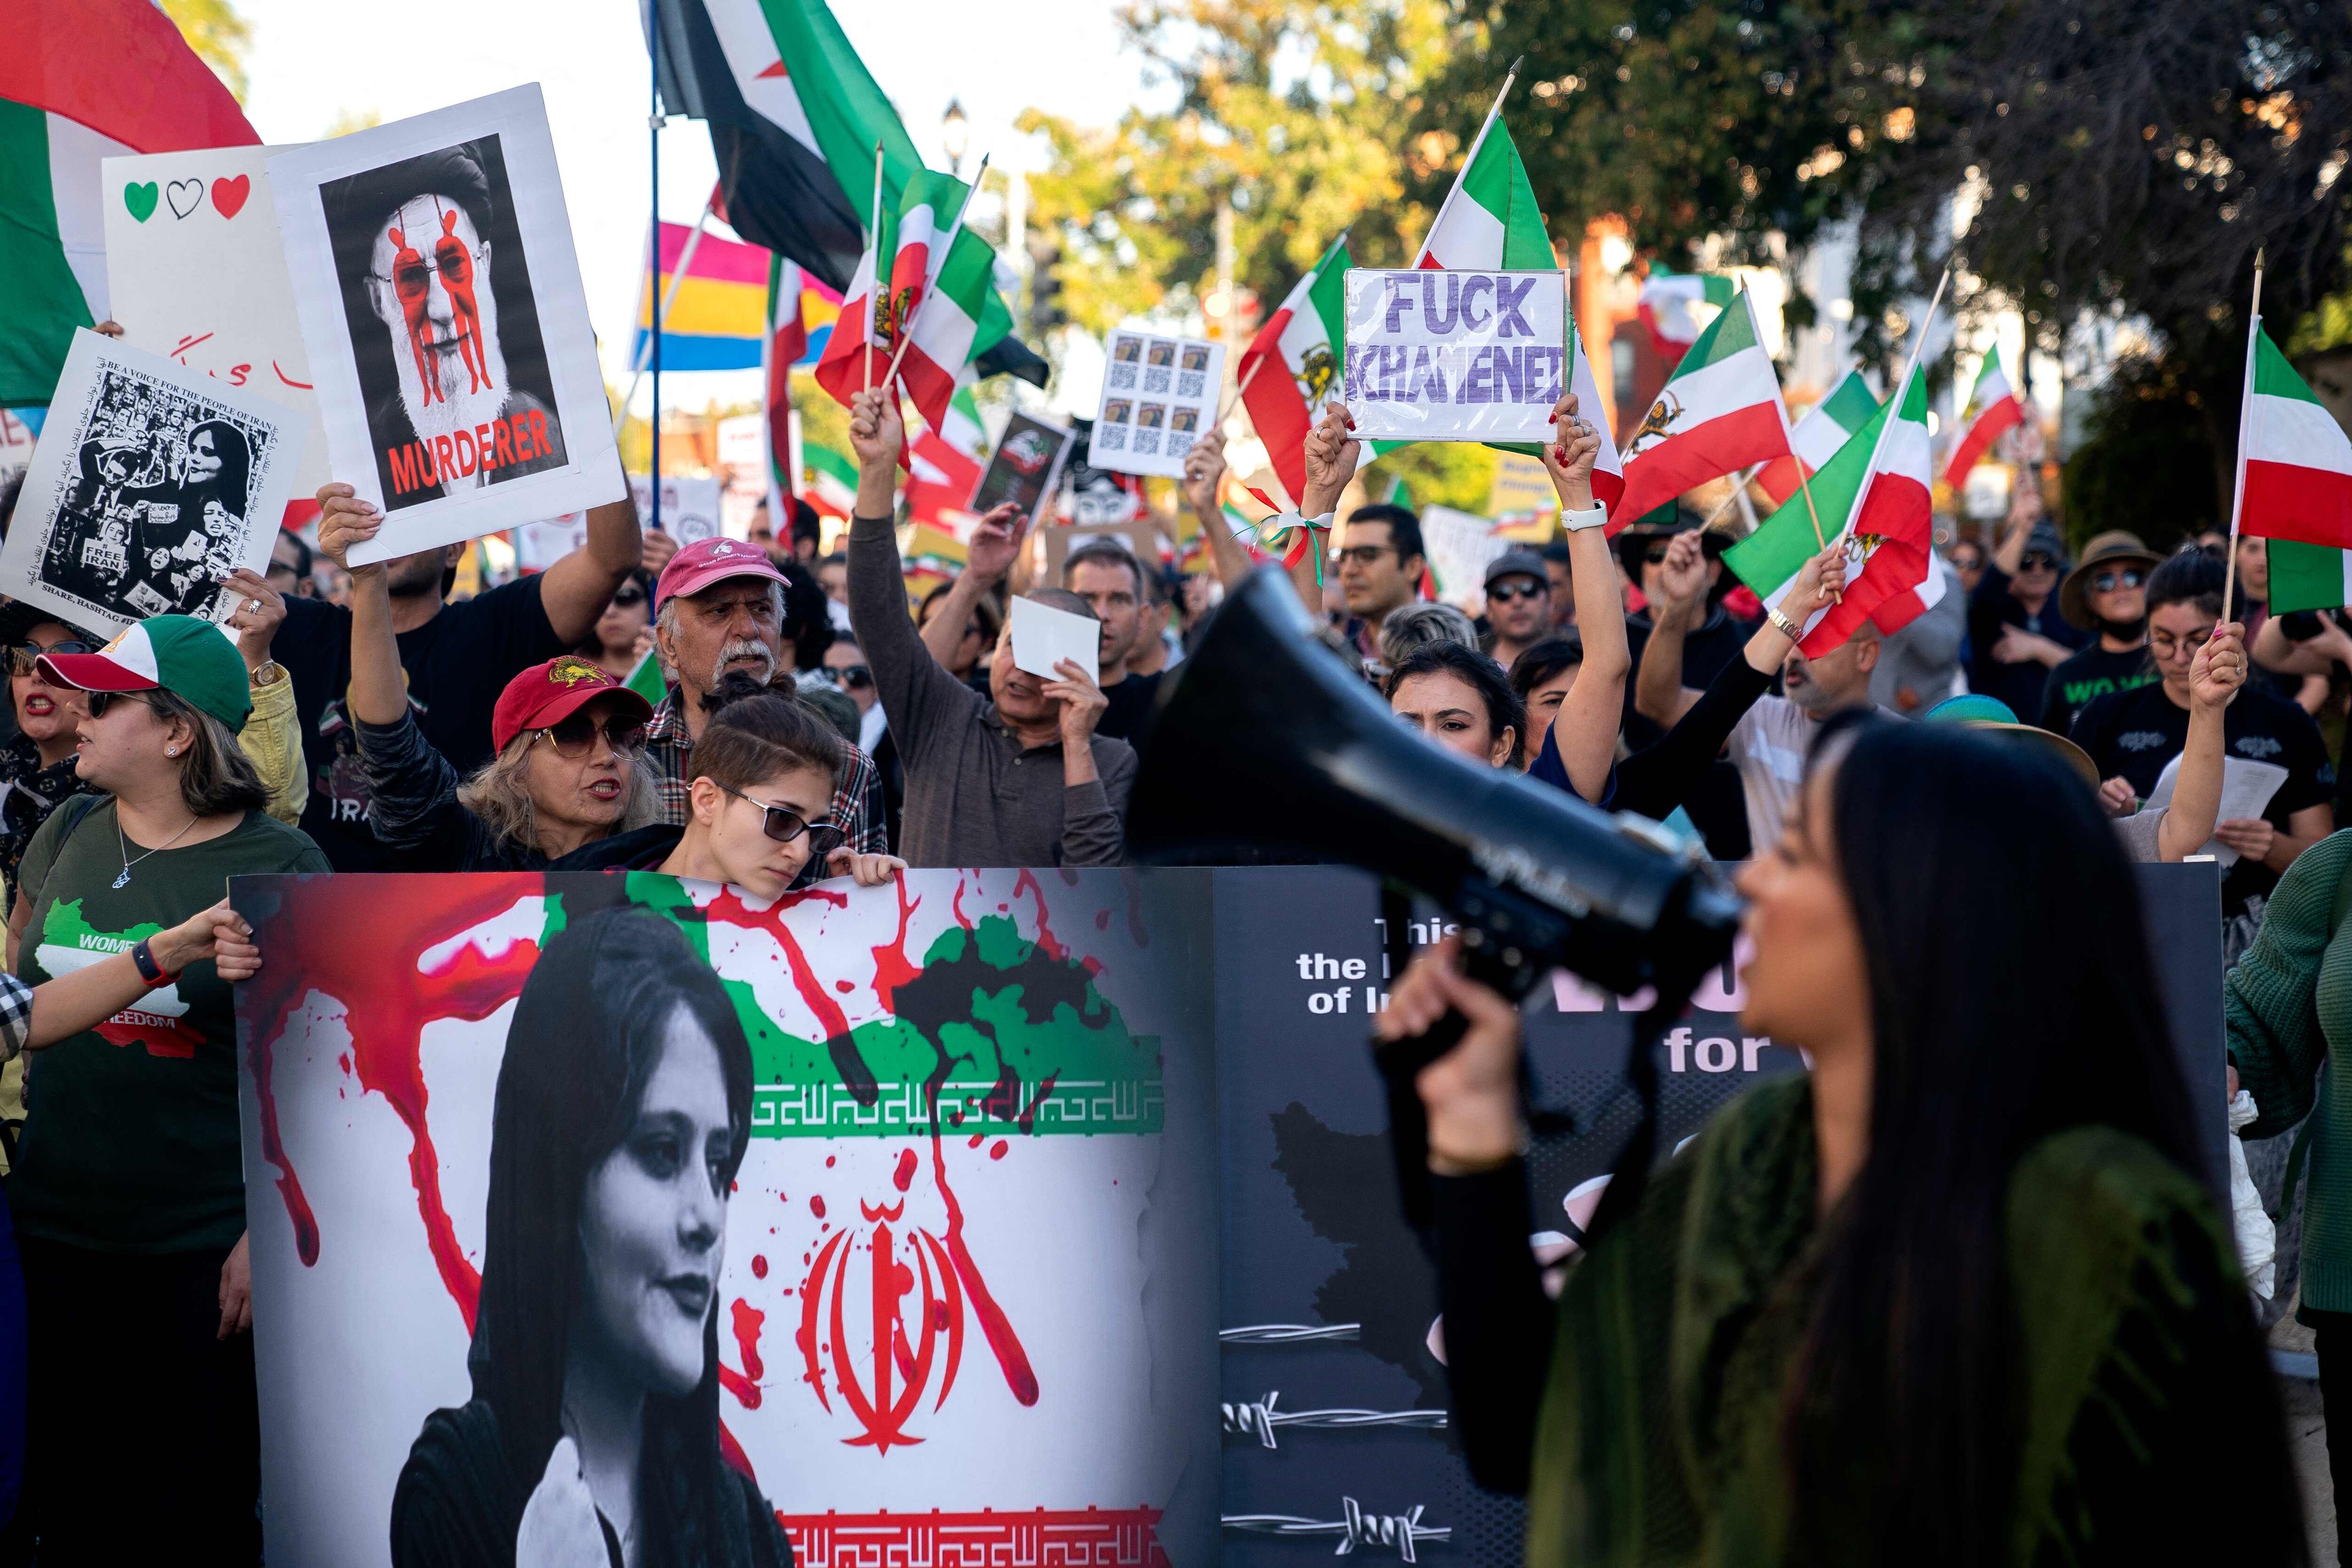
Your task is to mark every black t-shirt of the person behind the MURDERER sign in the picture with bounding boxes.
[270,576,569,872]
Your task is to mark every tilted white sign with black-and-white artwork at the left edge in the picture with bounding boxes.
[0,329,308,635]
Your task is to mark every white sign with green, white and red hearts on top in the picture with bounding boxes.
[101,148,334,510]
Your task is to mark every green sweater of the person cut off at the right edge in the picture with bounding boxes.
[2223,827,2352,1312]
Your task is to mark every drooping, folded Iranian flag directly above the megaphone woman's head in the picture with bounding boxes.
[1724,364,1947,658]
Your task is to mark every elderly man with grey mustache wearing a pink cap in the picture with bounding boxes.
[644,539,889,855]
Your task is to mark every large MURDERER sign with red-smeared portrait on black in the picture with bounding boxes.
[268,85,623,564]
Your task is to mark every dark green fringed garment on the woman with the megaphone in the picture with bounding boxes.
[1526,1077,2258,1568]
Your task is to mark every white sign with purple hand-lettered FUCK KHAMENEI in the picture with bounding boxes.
[1343,268,1569,442]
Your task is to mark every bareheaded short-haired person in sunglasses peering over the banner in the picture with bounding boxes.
[555,670,906,903]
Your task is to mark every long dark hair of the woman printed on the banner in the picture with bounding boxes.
[470,907,753,1563]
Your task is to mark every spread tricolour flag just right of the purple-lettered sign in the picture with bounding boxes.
[1609,289,1818,534]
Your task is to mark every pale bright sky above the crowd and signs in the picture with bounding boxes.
[238,0,1143,407]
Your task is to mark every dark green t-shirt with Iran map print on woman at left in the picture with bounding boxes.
[7,799,327,1253]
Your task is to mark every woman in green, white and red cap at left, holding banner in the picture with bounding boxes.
[7,616,332,1561]
